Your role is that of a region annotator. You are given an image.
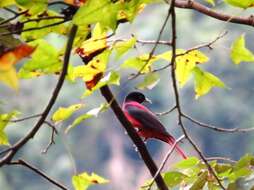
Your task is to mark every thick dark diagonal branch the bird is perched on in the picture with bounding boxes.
[100,86,168,190]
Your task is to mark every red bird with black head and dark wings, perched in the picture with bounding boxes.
[122,91,187,159]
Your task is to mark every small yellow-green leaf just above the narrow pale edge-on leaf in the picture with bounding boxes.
[52,104,83,122]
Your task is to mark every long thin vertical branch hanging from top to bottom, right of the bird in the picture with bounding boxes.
[170,0,226,190]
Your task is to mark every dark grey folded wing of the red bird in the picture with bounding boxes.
[125,106,168,134]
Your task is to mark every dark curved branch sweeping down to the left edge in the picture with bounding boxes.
[0,25,78,167]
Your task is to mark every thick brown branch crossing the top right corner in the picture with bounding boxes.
[175,0,254,26]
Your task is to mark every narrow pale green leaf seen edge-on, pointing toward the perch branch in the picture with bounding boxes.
[65,103,108,133]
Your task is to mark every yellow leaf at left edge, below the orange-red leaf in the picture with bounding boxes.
[0,66,19,90]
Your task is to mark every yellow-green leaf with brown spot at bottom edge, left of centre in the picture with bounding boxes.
[72,172,109,190]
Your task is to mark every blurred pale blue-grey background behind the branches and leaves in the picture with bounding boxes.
[0,2,254,190]
